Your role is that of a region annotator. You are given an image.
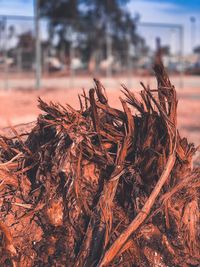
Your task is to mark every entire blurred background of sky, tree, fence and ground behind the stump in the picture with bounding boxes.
[0,0,200,151]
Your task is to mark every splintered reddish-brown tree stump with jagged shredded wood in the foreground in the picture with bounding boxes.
[0,62,200,267]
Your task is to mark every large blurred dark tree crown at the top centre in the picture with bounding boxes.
[40,0,143,70]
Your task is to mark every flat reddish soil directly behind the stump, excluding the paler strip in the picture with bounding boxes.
[0,83,200,149]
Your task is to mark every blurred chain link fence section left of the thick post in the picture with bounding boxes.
[0,16,36,89]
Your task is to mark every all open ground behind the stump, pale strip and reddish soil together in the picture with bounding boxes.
[0,77,200,151]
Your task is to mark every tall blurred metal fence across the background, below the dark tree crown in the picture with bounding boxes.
[0,16,183,90]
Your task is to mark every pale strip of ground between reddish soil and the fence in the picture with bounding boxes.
[0,73,200,89]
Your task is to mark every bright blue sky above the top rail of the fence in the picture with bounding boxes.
[0,0,200,51]
